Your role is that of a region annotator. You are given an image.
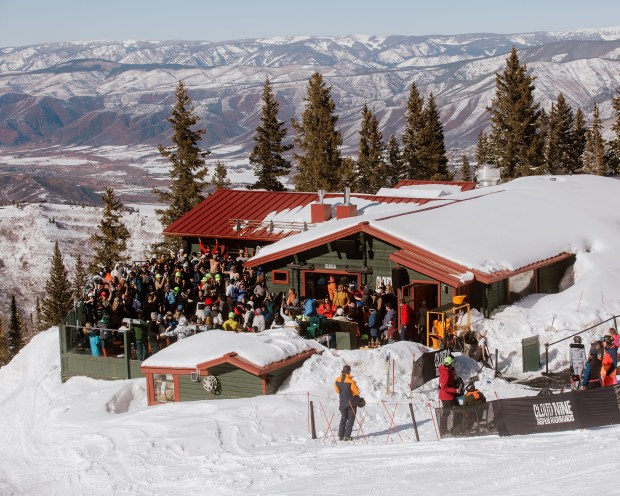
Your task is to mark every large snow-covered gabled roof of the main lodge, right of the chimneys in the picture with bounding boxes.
[251,175,620,274]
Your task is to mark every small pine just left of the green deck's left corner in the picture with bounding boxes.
[43,241,72,328]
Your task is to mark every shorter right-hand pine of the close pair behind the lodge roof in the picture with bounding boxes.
[418,93,452,181]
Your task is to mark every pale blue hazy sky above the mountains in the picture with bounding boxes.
[0,0,620,47]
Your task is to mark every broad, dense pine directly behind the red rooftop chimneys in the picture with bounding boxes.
[291,72,342,191]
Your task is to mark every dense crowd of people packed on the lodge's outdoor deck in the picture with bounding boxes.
[76,247,426,360]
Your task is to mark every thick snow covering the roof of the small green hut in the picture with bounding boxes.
[142,328,315,369]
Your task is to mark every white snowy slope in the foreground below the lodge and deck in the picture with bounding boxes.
[0,328,620,496]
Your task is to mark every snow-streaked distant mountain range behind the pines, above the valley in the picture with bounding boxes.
[0,27,620,159]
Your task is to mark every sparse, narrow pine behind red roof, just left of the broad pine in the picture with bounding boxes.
[250,79,293,191]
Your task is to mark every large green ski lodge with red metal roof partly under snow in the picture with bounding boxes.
[164,176,588,315]
